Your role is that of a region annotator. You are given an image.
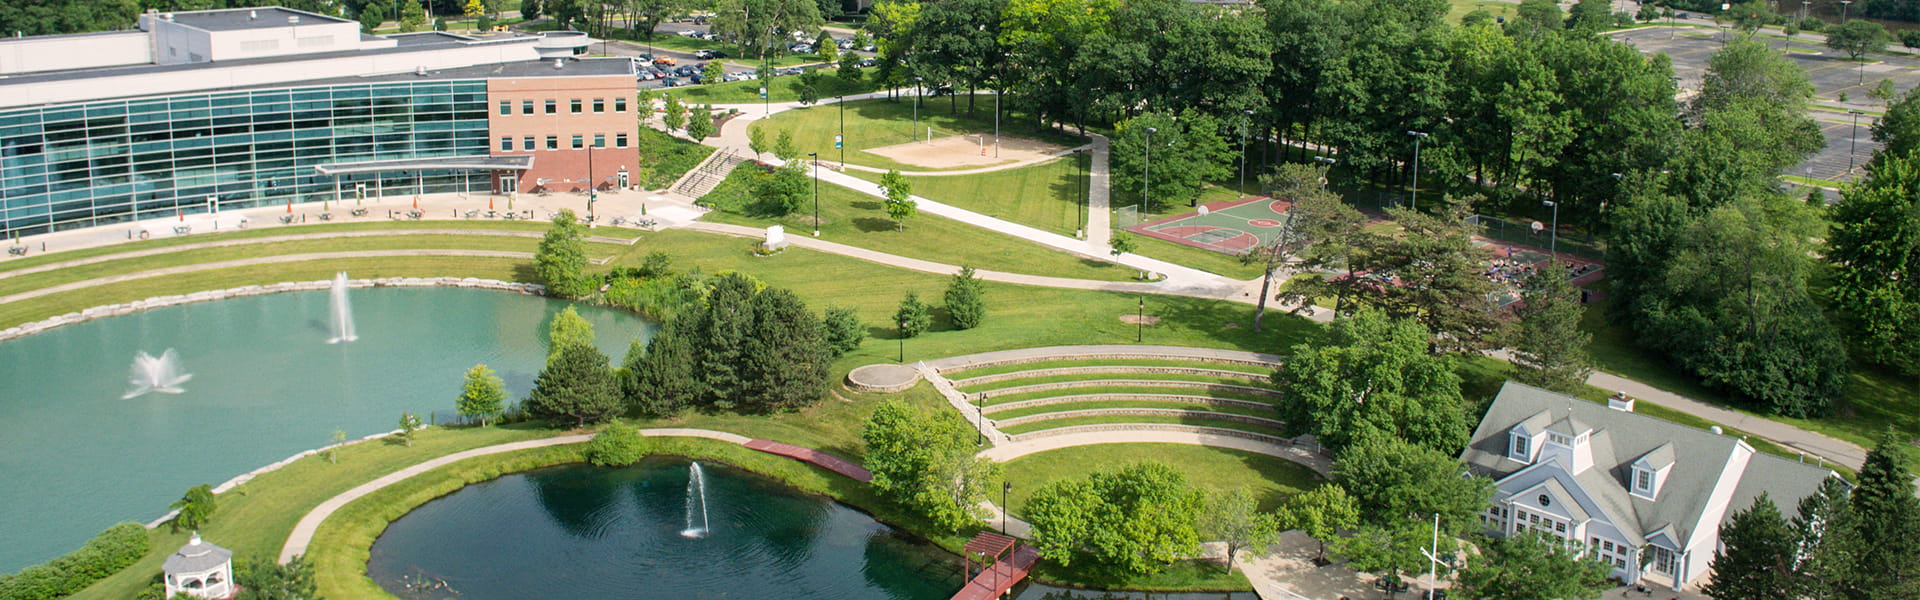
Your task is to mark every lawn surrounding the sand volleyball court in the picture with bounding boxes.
[753,94,1083,171]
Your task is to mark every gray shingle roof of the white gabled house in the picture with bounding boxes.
[1461,381,1832,544]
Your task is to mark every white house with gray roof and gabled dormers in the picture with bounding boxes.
[1461,381,1837,590]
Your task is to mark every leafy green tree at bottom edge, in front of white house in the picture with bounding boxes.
[1459,529,1612,600]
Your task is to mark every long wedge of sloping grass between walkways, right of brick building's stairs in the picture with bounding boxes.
[701,165,1137,282]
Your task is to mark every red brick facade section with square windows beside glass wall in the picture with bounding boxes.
[486,75,639,192]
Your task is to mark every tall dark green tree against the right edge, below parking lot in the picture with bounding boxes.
[1826,148,1920,375]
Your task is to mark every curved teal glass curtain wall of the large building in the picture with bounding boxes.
[0,79,490,237]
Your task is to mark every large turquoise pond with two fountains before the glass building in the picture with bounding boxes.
[0,288,653,573]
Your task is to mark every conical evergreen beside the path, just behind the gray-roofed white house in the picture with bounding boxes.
[1507,263,1594,394]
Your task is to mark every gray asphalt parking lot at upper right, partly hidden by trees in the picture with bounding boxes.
[1615,27,1920,181]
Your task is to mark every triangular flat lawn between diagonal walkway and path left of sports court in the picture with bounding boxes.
[847,156,1092,237]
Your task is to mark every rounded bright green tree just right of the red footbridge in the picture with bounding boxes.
[1025,462,1202,573]
